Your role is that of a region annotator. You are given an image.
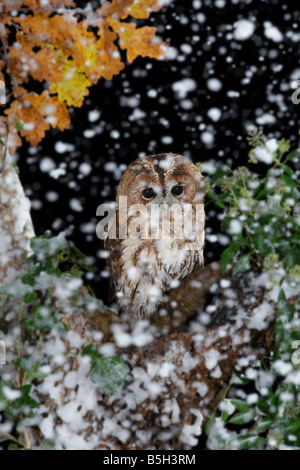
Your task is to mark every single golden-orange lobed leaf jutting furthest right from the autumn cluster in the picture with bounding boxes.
[108,18,165,62]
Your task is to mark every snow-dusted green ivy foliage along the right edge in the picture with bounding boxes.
[202,131,300,449]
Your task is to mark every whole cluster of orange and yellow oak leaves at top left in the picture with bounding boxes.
[0,0,169,152]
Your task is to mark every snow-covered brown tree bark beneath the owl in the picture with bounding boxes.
[29,265,275,450]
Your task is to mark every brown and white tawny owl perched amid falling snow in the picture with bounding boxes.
[105,153,205,318]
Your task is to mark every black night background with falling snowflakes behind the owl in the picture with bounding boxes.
[18,0,300,300]
